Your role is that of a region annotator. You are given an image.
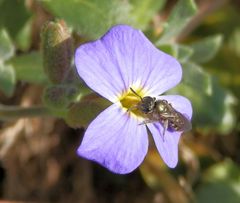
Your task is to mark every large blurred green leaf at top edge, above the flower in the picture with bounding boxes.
[42,0,132,39]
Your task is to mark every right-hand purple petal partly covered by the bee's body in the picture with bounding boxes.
[148,95,192,168]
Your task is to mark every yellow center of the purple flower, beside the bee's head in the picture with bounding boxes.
[119,88,146,119]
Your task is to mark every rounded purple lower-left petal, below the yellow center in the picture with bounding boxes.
[78,104,148,174]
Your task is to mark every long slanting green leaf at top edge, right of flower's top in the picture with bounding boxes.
[157,0,197,45]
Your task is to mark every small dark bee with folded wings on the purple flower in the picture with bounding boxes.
[128,88,192,138]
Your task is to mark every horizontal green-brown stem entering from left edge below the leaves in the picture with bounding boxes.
[0,105,51,120]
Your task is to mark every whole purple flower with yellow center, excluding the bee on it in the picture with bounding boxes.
[75,25,192,174]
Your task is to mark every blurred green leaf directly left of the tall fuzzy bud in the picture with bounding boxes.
[8,52,48,84]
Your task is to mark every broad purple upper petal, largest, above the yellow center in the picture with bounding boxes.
[75,25,182,102]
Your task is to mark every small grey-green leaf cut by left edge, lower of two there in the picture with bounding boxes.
[0,62,16,97]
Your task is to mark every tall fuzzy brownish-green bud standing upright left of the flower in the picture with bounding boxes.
[41,20,73,84]
